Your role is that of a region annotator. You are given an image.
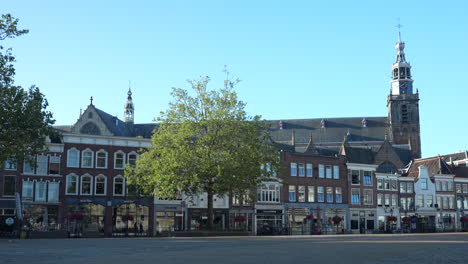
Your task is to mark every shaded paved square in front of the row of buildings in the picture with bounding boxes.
[0,233,468,264]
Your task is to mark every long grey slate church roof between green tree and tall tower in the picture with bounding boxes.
[267,117,388,144]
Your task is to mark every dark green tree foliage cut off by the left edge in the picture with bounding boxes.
[0,14,56,164]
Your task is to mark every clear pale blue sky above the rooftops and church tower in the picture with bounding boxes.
[1,0,468,156]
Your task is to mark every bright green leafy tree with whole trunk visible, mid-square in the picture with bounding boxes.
[127,71,279,229]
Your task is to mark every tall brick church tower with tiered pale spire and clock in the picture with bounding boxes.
[387,32,421,158]
